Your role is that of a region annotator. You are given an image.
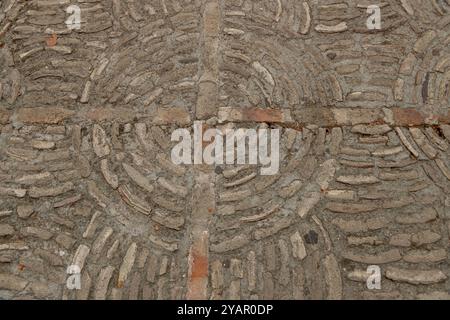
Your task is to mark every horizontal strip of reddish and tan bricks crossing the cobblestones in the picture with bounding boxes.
[0,107,450,127]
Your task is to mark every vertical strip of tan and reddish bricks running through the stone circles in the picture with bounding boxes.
[186,0,221,300]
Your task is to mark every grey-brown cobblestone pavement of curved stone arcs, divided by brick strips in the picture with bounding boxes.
[0,0,450,299]
